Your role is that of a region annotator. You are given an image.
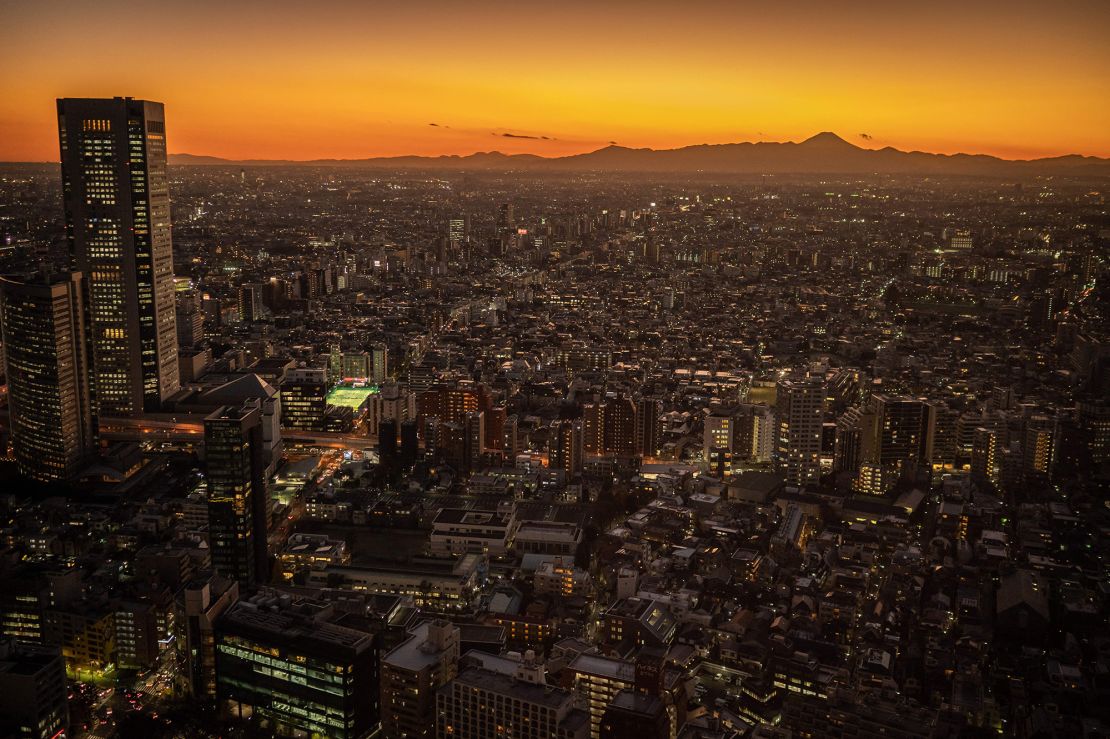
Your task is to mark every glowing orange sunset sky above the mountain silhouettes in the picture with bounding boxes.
[0,0,1110,161]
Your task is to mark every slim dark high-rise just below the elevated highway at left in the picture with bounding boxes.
[204,404,270,585]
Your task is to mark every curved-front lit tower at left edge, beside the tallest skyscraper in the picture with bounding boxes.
[0,273,95,480]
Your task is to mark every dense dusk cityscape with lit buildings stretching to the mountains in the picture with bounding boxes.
[0,98,1110,739]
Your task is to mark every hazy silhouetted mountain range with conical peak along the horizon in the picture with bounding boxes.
[170,132,1110,176]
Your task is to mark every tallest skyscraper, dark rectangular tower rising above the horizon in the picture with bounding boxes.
[58,98,179,416]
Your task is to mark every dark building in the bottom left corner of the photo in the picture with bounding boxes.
[0,640,69,739]
